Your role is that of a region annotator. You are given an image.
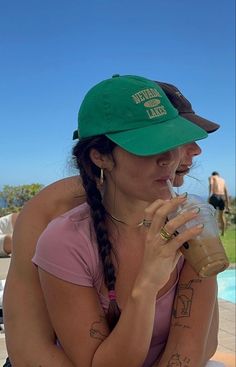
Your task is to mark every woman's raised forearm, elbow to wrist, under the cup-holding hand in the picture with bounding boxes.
[92,288,156,367]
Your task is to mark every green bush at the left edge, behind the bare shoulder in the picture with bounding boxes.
[0,183,43,216]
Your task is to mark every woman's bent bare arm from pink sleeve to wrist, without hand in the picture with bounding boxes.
[40,270,159,367]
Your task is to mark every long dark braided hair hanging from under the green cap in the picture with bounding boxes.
[72,135,120,331]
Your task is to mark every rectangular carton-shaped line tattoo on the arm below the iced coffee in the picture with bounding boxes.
[173,279,201,318]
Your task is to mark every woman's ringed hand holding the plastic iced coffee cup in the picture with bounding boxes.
[141,196,203,292]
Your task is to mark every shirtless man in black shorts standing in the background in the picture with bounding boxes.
[209,171,229,236]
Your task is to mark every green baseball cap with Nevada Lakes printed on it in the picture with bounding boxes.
[73,74,207,156]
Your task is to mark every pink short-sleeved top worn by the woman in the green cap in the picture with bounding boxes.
[32,204,184,367]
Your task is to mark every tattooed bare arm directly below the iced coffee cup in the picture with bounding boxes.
[158,263,218,367]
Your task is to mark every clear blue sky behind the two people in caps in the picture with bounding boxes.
[0,0,235,196]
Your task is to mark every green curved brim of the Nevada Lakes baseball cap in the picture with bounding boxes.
[106,116,207,156]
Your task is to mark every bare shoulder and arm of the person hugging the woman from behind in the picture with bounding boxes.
[4,177,85,367]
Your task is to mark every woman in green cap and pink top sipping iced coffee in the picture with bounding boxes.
[33,76,219,367]
